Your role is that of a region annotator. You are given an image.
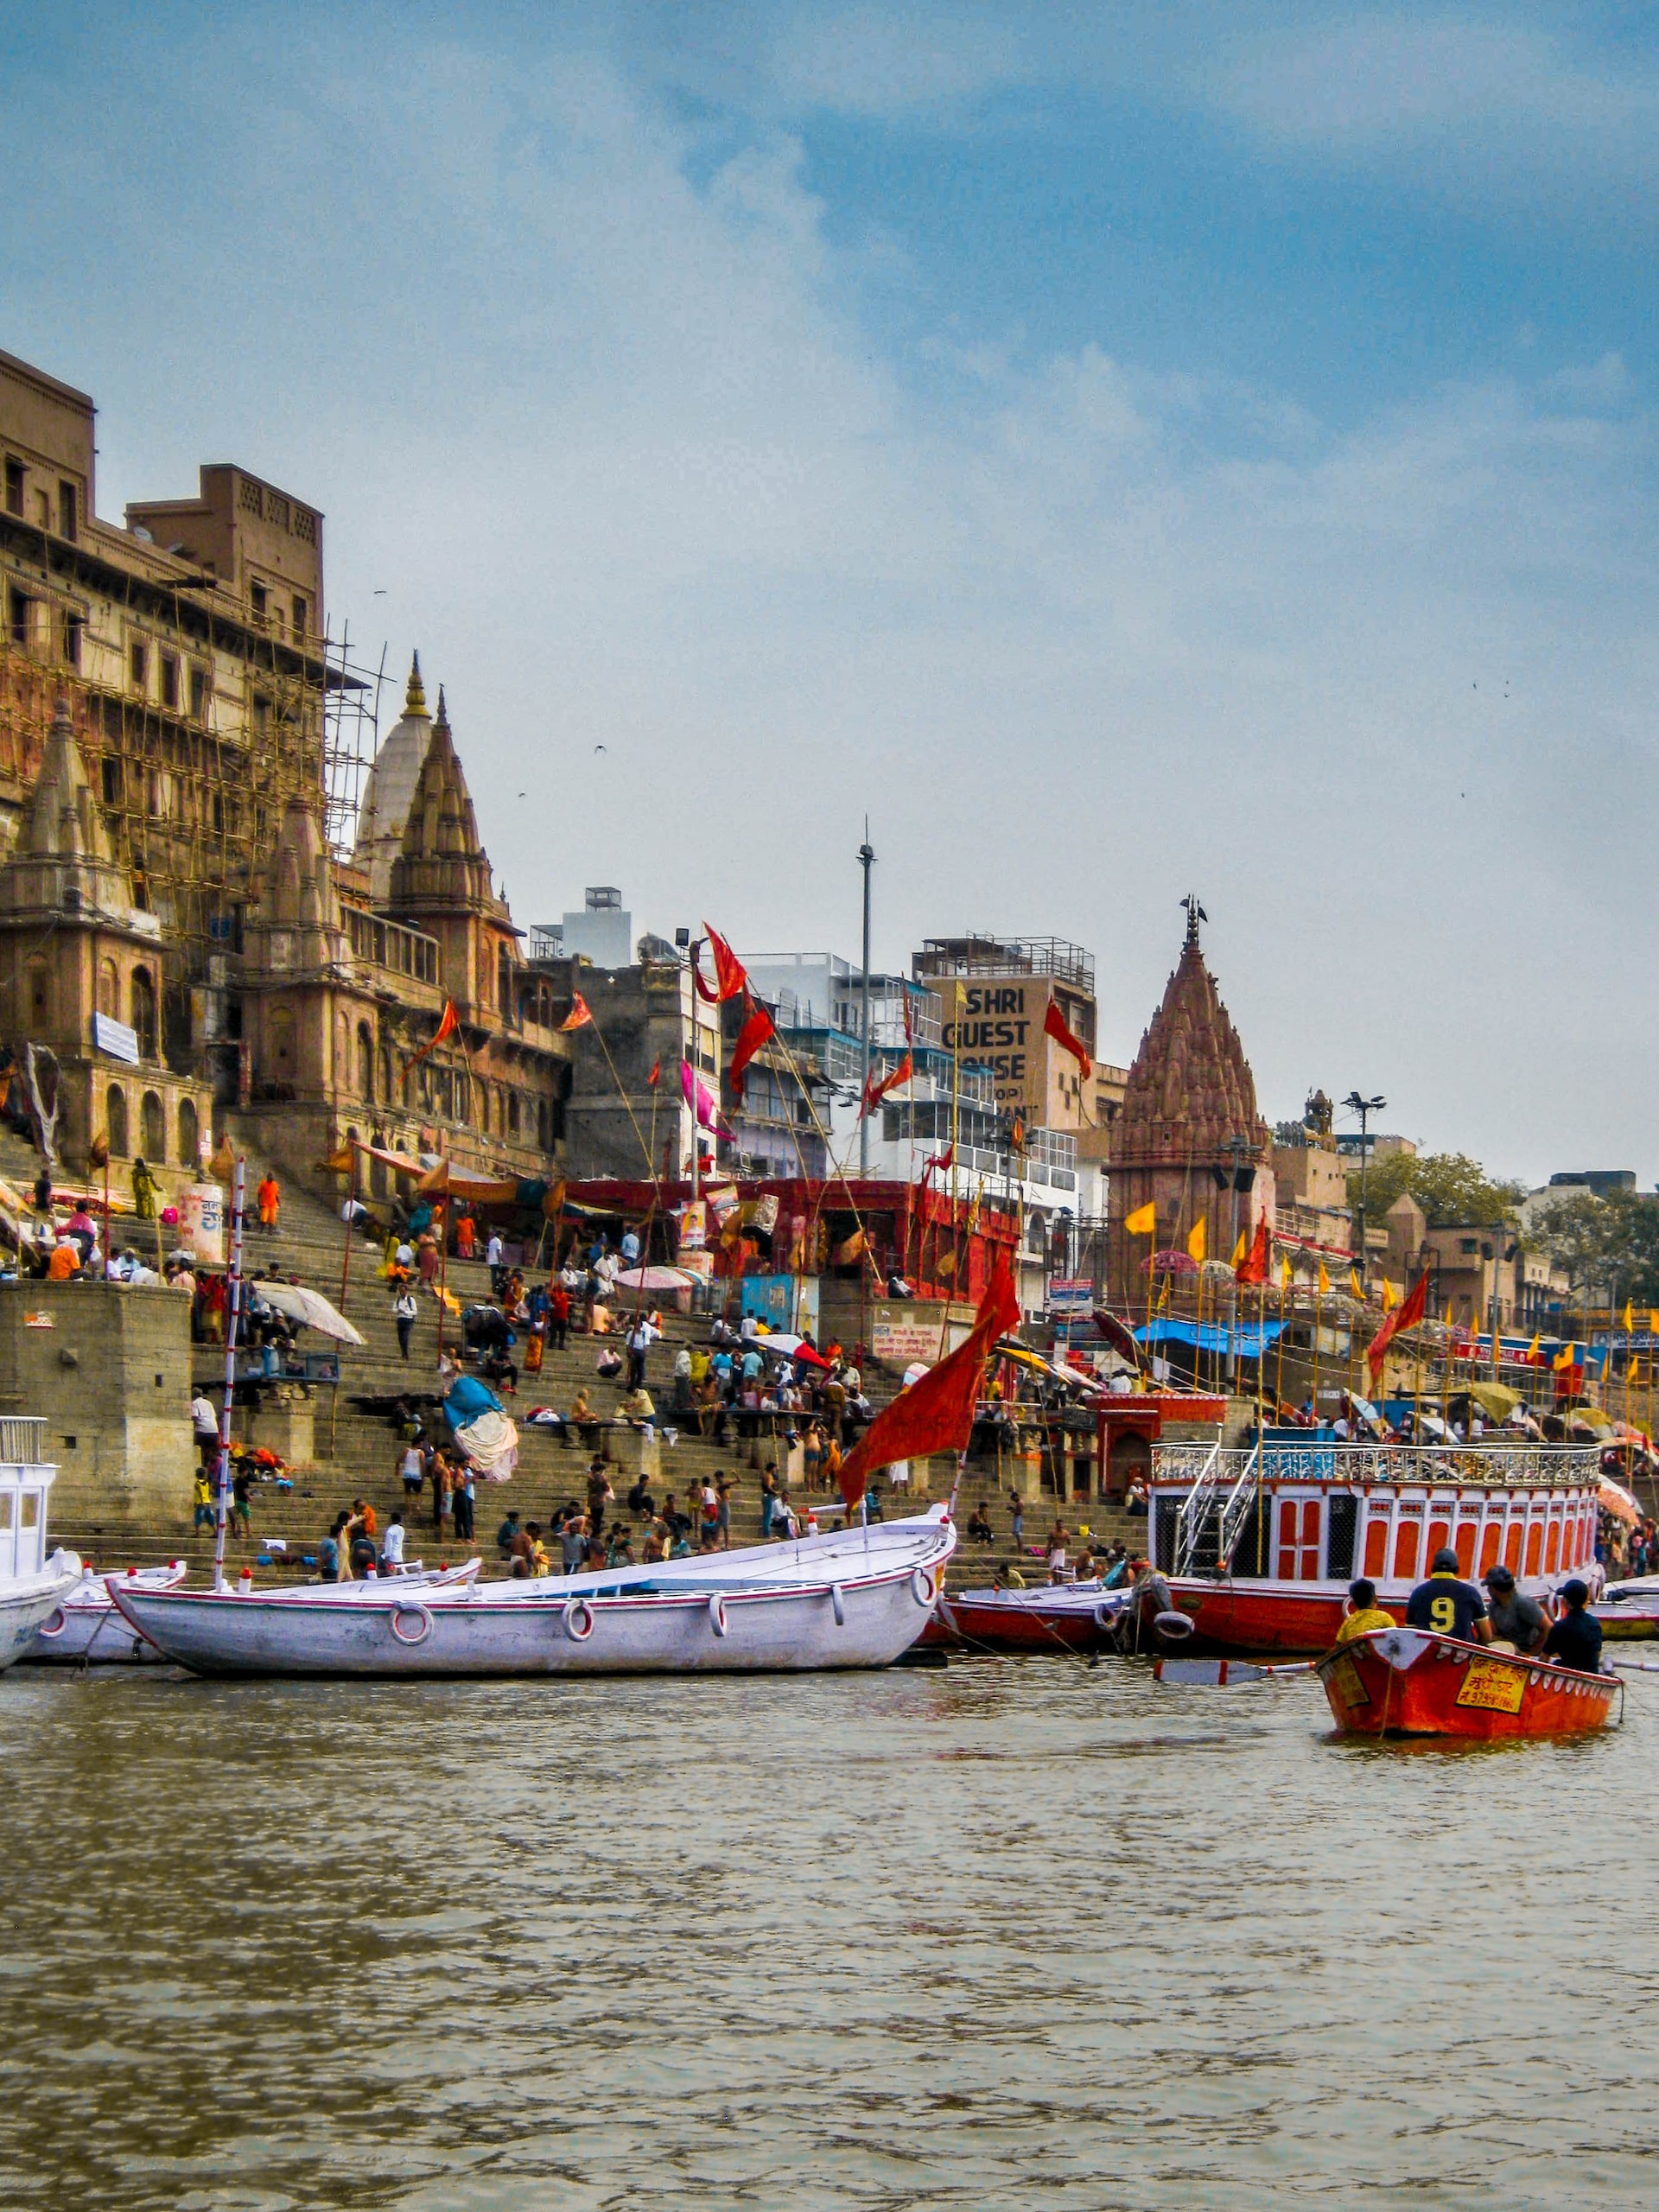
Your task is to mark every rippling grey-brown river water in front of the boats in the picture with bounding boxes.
[0,1659,1659,2212]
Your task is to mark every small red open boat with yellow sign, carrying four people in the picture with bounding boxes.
[1319,1628,1619,1743]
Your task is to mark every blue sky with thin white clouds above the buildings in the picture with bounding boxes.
[0,0,1659,1184]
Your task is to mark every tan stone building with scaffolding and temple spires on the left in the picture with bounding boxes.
[0,354,570,1174]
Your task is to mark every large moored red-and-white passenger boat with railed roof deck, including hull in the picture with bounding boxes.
[1148,1431,1601,1652]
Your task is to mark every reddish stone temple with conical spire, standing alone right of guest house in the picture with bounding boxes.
[1106,900,1274,1307]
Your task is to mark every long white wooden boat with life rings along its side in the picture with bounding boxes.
[113,1506,956,1675]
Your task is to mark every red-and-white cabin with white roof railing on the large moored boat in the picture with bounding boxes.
[1148,1440,1601,1584]
